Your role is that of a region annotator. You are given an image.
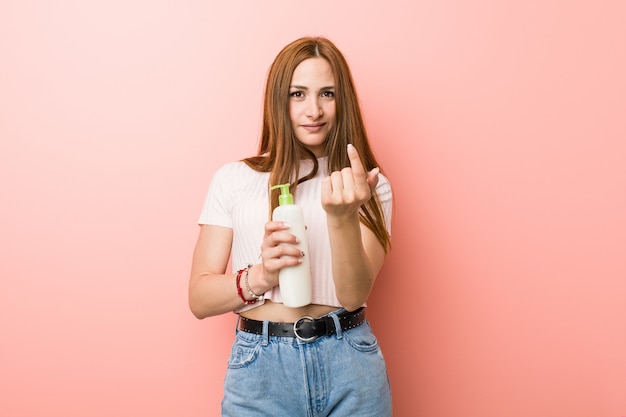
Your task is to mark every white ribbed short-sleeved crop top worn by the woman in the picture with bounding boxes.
[198,157,392,312]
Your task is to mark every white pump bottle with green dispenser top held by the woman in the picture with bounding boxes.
[271,184,312,307]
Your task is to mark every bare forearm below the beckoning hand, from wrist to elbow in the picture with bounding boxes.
[328,214,378,311]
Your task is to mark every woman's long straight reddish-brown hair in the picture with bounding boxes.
[244,37,390,251]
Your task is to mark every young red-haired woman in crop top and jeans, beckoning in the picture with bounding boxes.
[189,38,392,417]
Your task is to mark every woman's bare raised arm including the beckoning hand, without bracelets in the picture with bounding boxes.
[322,145,385,311]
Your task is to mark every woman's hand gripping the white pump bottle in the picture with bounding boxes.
[260,221,306,290]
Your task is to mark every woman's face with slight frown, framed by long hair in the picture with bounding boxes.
[289,58,335,158]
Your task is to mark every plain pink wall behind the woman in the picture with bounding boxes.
[0,0,626,417]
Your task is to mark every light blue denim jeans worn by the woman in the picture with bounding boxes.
[222,309,391,417]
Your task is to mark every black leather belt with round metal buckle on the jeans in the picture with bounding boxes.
[239,307,365,342]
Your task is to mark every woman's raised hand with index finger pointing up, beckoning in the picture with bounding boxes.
[322,144,379,218]
